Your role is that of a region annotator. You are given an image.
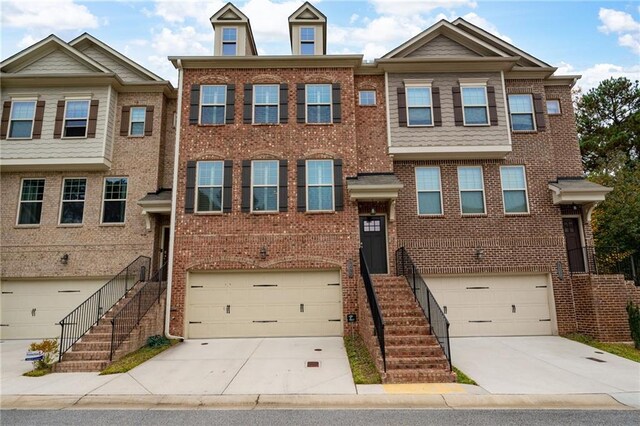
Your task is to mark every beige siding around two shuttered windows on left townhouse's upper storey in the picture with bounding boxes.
[0,86,115,161]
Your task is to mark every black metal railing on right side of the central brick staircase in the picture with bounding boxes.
[396,247,452,369]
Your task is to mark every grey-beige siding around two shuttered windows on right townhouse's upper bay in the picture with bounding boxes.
[389,73,509,147]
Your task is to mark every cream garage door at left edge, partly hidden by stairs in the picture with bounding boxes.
[0,278,108,339]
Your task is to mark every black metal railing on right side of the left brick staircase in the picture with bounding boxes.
[109,265,167,360]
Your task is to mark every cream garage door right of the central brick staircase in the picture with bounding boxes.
[423,275,552,337]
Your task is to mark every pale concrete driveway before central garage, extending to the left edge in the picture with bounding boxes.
[0,337,356,395]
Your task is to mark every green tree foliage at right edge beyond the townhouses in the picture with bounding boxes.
[576,77,640,253]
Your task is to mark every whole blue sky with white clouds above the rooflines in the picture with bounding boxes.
[0,0,640,90]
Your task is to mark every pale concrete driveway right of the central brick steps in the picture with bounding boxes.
[451,336,640,405]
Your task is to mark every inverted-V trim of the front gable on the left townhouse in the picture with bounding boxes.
[0,34,112,74]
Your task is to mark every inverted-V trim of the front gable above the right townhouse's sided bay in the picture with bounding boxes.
[382,19,512,59]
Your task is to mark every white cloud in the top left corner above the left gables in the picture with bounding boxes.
[2,0,100,33]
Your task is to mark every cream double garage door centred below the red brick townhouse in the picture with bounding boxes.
[186,271,342,338]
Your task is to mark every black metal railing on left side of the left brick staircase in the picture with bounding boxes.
[58,256,151,361]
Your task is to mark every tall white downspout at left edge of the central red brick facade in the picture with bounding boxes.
[164,59,184,341]
